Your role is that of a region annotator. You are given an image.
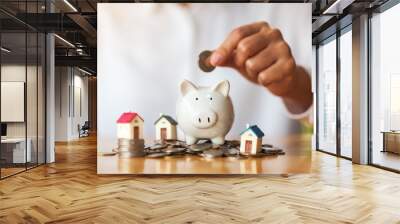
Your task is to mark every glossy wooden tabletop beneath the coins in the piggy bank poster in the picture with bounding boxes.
[97,135,311,174]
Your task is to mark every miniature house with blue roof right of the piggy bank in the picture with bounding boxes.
[240,125,264,154]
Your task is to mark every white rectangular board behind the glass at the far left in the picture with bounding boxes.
[1,82,25,122]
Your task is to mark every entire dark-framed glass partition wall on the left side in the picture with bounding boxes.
[0,1,46,178]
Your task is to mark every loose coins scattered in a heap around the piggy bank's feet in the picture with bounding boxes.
[145,140,285,159]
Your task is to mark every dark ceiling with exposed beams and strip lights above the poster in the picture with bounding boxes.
[0,0,387,72]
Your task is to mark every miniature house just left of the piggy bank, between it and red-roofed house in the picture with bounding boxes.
[154,114,178,140]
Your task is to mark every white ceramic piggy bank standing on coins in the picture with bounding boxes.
[177,80,234,145]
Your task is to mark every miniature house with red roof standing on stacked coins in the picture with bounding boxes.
[117,112,144,139]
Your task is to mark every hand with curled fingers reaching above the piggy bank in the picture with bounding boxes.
[210,22,297,97]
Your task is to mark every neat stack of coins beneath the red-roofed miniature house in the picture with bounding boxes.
[118,138,145,157]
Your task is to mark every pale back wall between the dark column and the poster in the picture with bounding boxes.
[55,67,88,141]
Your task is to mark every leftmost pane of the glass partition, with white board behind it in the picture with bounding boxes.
[0,32,27,177]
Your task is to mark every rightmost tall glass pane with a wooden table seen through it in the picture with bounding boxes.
[370,4,400,171]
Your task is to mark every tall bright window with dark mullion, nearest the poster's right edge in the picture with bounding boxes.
[317,24,353,159]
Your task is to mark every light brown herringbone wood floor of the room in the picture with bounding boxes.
[0,138,400,224]
